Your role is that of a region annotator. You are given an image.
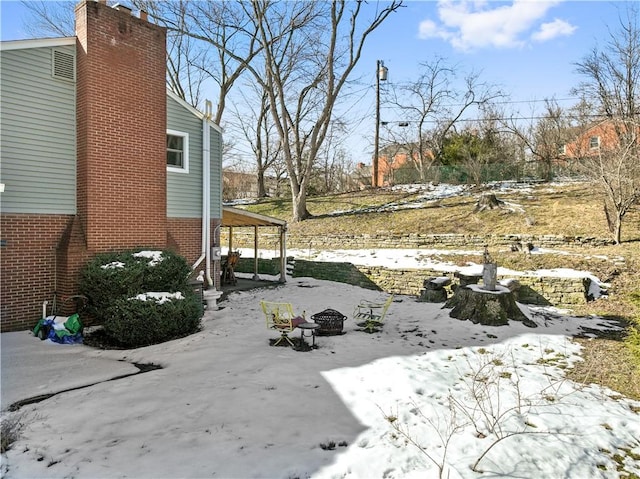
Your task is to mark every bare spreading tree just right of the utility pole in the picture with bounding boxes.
[394,58,502,181]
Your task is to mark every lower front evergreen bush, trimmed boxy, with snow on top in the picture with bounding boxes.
[104,291,202,347]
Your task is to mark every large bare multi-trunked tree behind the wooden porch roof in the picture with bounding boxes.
[241,0,402,222]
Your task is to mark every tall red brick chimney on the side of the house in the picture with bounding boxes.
[75,0,167,253]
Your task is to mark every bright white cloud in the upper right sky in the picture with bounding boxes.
[419,0,575,51]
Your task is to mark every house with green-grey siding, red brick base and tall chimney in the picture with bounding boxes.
[0,0,222,331]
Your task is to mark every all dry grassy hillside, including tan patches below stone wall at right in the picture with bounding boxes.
[244,183,640,399]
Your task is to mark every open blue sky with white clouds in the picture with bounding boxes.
[0,0,627,161]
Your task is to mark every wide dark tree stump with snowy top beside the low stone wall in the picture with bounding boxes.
[444,284,537,328]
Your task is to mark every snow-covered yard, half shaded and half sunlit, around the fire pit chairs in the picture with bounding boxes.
[2,278,640,479]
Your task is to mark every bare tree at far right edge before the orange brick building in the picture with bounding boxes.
[573,4,640,248]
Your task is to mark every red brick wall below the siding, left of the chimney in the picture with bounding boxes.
[0,214,73,331]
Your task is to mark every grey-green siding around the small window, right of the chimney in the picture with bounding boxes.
[167,96,222,218]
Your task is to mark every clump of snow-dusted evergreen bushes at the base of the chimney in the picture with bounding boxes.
[80,248,202,347]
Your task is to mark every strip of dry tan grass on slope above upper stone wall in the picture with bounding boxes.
[247,183,640,242]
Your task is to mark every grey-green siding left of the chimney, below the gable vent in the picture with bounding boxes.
[0,45,76,214]
